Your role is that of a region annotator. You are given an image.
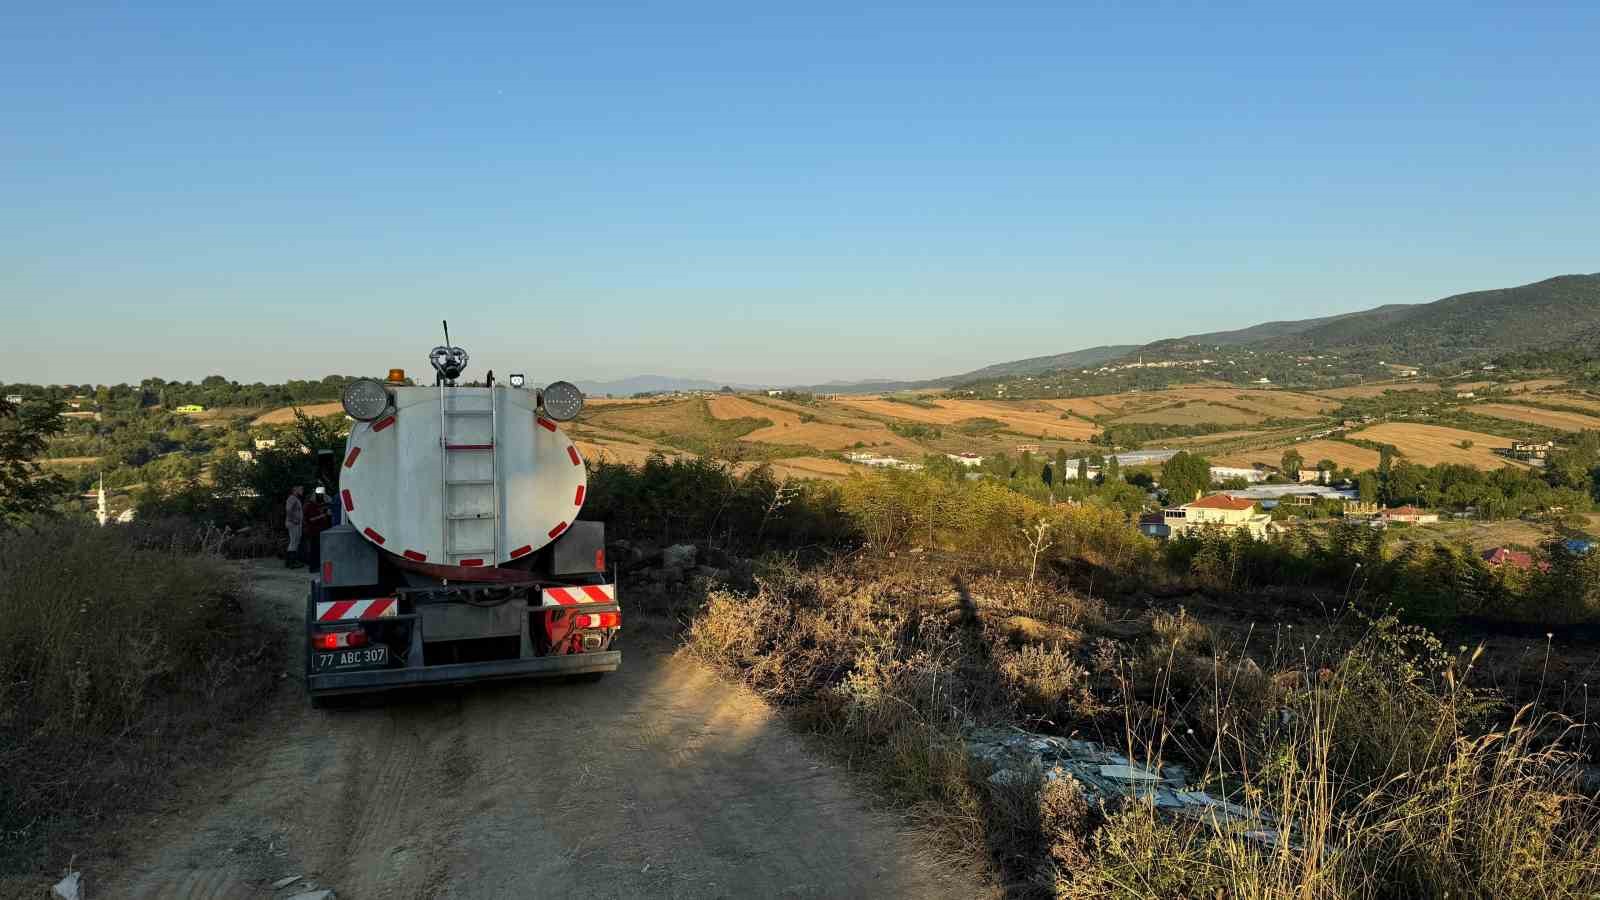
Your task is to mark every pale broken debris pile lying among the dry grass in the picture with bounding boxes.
[966,729,1283,846]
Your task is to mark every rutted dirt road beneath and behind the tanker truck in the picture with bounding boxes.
[109,565,986,900]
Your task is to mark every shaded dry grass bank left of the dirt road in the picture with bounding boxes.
[0,522,282,876]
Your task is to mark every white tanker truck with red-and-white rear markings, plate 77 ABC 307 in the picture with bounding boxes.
[306,327,622,705]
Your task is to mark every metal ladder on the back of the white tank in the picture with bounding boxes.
[438,383,502,565]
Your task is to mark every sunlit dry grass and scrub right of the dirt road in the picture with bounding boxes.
[688,565,1600,900]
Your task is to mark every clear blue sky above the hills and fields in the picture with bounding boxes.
[0,2,1600,383]
